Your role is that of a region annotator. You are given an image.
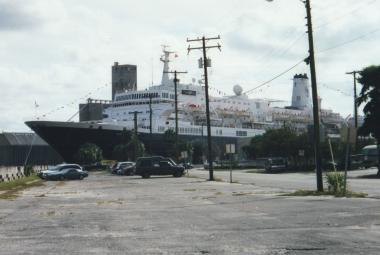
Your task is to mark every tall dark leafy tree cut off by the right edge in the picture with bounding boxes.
[357,66,380,177]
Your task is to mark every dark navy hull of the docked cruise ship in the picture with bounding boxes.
[25,121,242,162]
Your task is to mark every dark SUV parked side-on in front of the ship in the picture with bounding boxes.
[136,156,185,178]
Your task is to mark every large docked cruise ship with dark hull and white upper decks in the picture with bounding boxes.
[26,49,340,161]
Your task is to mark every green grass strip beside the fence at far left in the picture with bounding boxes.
[0,175,43,199]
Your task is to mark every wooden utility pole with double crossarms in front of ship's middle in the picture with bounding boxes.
[187,36,221,181]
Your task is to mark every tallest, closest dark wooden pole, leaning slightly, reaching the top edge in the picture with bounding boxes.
[266,0,323,192]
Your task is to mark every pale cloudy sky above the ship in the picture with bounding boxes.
[0,0,380,132]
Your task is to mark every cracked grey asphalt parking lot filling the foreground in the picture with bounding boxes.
[0,170,380,254]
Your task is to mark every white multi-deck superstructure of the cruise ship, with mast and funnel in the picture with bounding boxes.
[102,49,341,138]
